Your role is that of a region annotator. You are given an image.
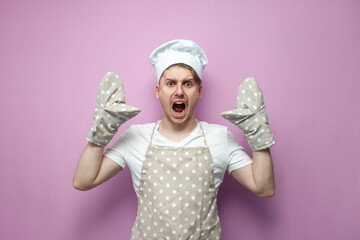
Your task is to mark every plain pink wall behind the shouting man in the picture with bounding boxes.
[0,0,360,240]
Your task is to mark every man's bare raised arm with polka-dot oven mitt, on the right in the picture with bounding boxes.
[222,78,275,197]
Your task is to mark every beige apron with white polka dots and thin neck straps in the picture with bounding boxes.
[131,123,221,240]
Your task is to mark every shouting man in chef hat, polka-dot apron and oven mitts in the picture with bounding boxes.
[74,40,275,239]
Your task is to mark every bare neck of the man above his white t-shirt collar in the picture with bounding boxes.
[158,118,197,142]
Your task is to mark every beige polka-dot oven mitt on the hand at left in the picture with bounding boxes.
[86,72,141,146]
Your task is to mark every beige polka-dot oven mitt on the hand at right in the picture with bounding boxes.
[221,78,275,151]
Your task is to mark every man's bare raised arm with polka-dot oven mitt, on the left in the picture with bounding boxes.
[73,72,141,190]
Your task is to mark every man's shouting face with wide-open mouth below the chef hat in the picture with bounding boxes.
[155,65,202,124]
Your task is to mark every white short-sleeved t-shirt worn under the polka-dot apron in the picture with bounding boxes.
[104,122,252,195]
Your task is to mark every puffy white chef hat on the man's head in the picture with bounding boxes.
[149,40,208,82]
